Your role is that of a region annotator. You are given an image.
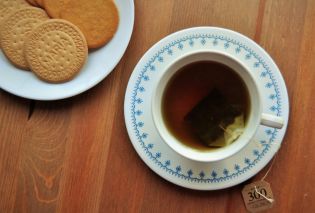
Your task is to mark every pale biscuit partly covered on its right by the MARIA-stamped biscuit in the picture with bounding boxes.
[0,7,48,69]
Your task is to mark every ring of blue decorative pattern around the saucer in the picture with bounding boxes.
[131,34,281,183]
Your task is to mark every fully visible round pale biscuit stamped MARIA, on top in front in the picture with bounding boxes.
[25,19,88,83]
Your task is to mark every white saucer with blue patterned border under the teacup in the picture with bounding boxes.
[124,27,289,190]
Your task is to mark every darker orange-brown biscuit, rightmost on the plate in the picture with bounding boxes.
[60,0,119,48]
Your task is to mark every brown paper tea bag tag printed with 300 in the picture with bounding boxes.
[242,180,275,212]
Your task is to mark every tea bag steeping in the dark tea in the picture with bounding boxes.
[185,89,244,147]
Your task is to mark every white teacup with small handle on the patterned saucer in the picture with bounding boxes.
[152,50,284,162]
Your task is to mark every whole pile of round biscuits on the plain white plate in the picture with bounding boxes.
[0,0,119,83]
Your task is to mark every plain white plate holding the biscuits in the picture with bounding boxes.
[0,0,134,100]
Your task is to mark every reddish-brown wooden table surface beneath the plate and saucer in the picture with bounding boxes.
[0,0,315,212]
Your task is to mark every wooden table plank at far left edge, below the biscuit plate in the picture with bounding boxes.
[0,91,29,212]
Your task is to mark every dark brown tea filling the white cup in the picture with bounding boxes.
[162,61,250,150]
